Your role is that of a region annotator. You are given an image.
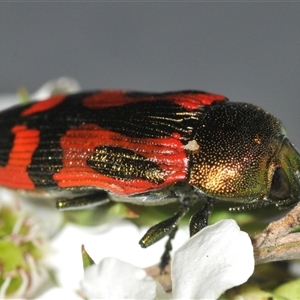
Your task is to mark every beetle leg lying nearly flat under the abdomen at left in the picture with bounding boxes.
[56,191,110,210]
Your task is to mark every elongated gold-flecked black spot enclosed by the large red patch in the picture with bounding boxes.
[87,146,165,184]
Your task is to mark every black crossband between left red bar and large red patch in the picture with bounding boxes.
[24,93,92,188]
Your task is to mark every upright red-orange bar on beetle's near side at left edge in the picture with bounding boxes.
[0,125,40,190]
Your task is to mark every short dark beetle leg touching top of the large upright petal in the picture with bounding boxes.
[190,198,214,236]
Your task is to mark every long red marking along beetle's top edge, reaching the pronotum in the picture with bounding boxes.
[82,90,227,110]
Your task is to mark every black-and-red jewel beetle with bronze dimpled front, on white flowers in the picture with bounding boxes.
[0,90,300,268]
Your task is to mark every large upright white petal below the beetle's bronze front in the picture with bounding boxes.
[172,220,254,299]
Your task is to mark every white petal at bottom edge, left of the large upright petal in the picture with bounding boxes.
[80,258,168,299]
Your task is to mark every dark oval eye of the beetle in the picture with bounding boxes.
[269,168,291,200]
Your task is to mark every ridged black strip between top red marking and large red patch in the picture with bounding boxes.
[80,97,200,140]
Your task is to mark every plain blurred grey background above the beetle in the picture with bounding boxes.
[0,1,300,148]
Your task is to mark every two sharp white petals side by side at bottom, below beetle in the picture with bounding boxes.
[81,220,254,299]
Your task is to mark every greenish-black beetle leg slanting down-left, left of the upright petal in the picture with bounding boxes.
[139,204,190,248]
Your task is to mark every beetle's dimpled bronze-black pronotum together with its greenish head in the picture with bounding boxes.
[189,103,300,207]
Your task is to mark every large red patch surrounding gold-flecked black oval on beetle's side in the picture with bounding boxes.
[53,124,188,195]
